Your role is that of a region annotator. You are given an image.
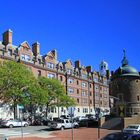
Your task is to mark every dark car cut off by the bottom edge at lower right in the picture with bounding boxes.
[101,132,132,140]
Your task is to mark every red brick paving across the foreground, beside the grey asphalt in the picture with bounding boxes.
[9,128,118,140]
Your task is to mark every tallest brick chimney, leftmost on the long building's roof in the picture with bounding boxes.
[2,29,13,46]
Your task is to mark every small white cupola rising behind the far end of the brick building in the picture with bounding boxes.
[99,60,108,76]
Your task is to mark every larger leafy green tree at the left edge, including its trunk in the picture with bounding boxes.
[0,61,37,118]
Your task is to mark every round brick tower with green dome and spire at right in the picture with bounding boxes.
[110,50,140,116]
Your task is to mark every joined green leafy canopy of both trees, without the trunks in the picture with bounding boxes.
[0,61,75,118]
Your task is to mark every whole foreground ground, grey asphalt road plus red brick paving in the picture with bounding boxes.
[0,126,120,140]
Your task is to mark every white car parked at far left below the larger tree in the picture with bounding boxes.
[1,119,29,128]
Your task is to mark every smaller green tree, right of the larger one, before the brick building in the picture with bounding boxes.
[38,77,75,117]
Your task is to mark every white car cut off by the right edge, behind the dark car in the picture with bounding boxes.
[123,124,140,134]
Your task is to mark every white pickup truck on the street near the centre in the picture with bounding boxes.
[48,118,79,130]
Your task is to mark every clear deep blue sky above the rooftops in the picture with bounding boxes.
[0,0,140,71]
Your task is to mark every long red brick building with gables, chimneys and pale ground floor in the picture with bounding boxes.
[0,30,109,118]
